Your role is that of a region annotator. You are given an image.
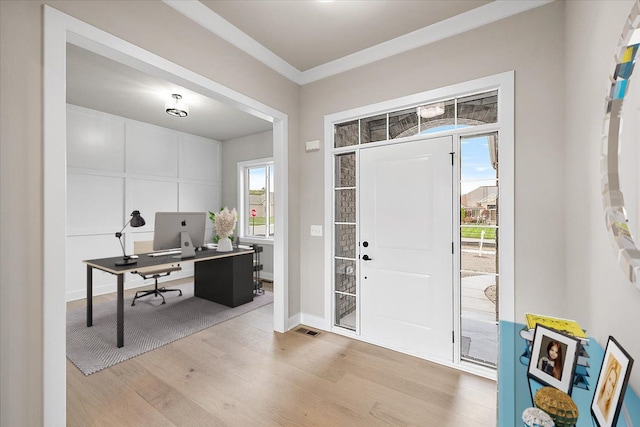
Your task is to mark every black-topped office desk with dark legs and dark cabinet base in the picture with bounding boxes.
[83,249,253,348]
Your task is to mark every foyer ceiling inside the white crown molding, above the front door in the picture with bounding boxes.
[201,0,491,71]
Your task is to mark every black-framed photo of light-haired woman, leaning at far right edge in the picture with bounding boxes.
[591,336,633,427]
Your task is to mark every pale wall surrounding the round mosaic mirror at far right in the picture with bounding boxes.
[564,1,640,392]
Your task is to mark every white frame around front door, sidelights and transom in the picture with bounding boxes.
[324,71,515,376]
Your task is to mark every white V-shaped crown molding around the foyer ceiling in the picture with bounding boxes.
[163,0,553,85]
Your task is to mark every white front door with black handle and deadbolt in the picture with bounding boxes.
[359,137,453,362]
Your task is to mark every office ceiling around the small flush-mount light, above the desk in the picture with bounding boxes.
[67,44,272,141]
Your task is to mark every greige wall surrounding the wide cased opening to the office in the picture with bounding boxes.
[0,0,300,426]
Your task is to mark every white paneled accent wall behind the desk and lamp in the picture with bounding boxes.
[66,105,221,301]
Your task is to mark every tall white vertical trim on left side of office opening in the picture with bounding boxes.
[42,5,67,427]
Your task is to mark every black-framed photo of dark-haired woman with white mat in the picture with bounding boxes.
[527,324,580,395]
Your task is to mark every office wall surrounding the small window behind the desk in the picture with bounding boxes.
[221,131,278,280]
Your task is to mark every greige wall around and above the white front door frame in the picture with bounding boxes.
[298,2,566,321]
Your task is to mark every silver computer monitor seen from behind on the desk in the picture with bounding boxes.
[153,212,207,258]
